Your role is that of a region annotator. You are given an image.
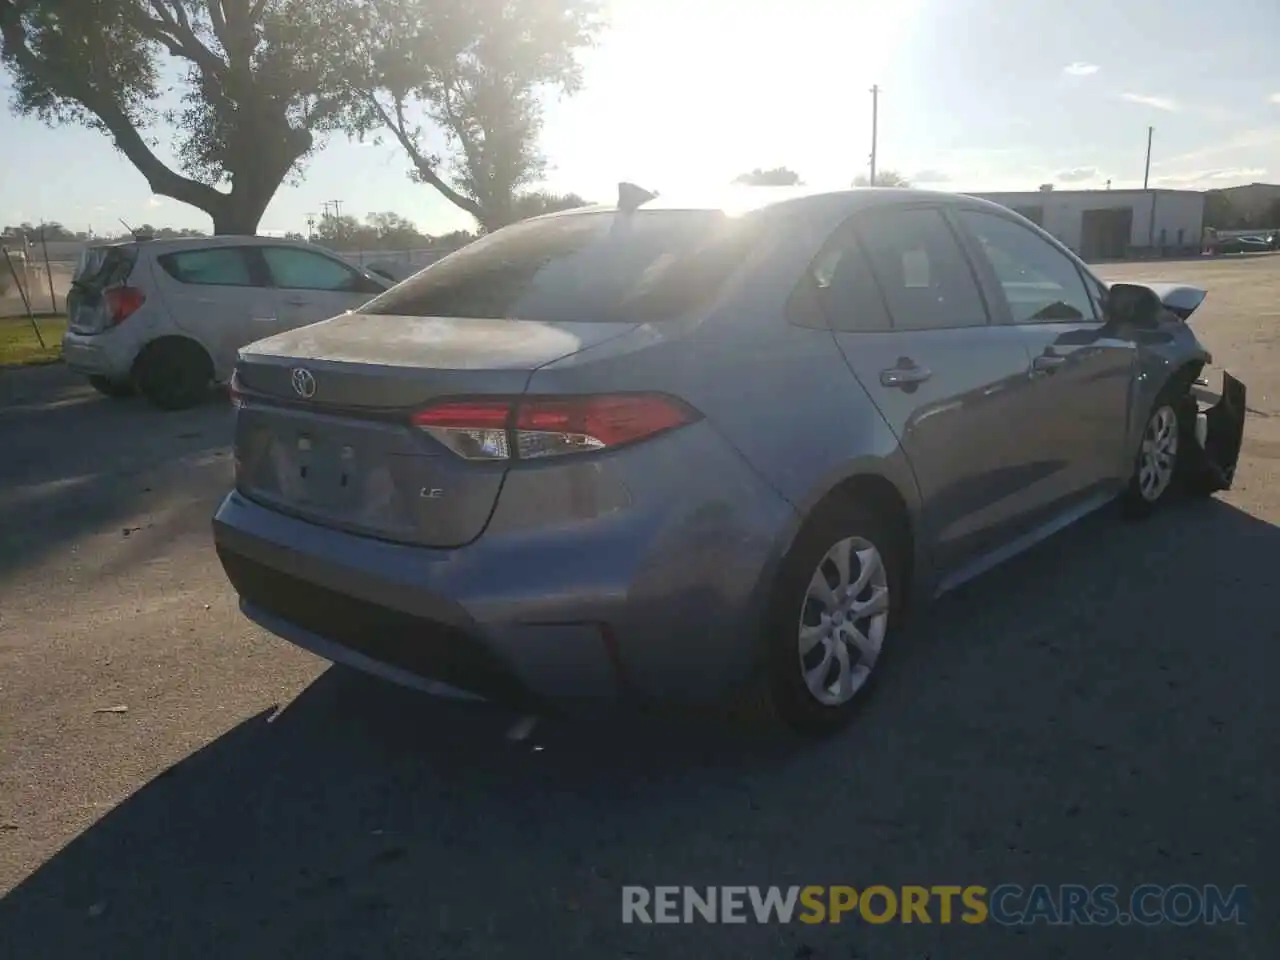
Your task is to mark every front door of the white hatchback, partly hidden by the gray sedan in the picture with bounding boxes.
[259,244,390,330]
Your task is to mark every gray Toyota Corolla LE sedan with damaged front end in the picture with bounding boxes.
[214,184,1244,732]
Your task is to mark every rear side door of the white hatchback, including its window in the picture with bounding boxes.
[154,244,276,379]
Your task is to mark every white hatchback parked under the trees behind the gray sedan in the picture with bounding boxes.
[63,237,394,410]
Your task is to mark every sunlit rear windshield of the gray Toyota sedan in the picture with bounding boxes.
[358,210,758,323]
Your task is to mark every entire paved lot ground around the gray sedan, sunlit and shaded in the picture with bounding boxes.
[0,256,1280,960]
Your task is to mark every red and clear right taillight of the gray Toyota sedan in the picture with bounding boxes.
[413,393,696,460]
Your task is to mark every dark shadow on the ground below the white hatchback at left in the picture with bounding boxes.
[0,366,232,579]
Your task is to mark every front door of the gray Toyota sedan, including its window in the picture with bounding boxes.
[955,209,1138,511]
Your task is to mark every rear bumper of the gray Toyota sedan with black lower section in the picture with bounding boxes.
[212,445,790,703]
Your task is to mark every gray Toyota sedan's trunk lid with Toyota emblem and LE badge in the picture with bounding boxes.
[236,314,635,548]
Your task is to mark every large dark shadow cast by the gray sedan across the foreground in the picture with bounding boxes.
[0,500,1280,957]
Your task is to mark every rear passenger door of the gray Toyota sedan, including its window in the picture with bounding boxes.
[814,206,1039,576]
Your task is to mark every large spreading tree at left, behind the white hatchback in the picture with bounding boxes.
[0,0,360,233]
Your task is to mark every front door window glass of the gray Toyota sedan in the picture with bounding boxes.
[959,210,1097,324]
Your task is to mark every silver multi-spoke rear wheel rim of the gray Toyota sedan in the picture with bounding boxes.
[799,536,890,707]
